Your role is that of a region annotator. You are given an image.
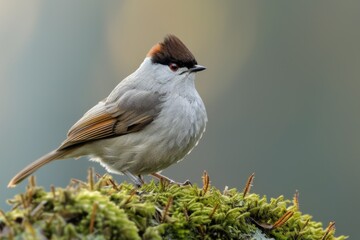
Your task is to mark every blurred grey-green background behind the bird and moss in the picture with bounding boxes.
[0,0,360,236]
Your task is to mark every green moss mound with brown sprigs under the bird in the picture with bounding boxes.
[0,174,346,239]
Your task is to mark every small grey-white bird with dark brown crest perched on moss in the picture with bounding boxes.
[8,35,207,187]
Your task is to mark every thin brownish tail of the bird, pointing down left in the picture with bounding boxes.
[8,150,68,188]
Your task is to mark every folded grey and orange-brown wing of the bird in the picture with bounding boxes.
[59,90,161,150]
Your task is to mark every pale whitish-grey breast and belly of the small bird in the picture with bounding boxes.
[83,89,207,175]
